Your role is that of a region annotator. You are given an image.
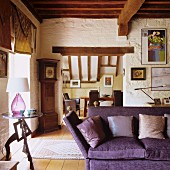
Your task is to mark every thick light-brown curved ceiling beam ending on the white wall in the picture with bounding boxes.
[118,0,145,36]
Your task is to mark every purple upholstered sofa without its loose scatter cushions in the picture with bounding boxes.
[64,106,170,170]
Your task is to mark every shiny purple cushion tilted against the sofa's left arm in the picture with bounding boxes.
[77,116,106,148]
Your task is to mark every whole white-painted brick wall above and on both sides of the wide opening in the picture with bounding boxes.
[40,18,170,114]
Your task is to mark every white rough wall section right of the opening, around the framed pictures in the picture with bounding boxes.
[123,19,170,106]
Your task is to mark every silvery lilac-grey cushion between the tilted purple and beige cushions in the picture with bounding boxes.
[108,116,133,137]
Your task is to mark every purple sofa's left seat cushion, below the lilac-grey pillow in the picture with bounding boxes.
[88,137,145,159]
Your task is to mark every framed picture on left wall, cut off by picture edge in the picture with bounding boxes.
[0,50,8,77]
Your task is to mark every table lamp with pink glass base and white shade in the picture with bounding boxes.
[6,77,29,115]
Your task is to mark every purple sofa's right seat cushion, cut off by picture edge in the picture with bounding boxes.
[141,138,170,160]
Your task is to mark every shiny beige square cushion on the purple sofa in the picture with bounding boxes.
[139,114,165,139]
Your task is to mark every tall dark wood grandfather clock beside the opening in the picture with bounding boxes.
[37,58,60,133]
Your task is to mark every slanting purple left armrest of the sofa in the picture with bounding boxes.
[64,111,90,158]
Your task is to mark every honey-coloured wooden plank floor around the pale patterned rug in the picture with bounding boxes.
[10,119,85,170]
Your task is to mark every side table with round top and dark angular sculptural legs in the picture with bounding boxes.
[2,113,43,170]
